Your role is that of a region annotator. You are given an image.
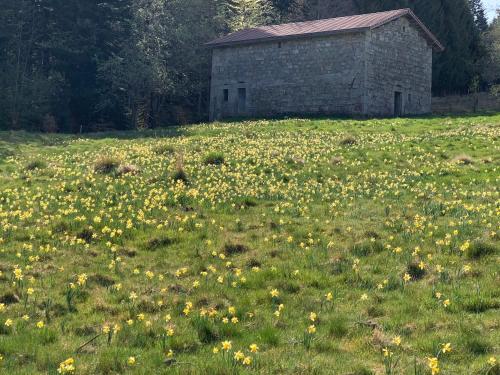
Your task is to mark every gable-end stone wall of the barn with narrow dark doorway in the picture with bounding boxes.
[366,18,432,116]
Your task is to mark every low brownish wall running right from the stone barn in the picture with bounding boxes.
[432,92,500,114]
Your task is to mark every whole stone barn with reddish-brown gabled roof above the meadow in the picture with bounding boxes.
[207,9,443,120]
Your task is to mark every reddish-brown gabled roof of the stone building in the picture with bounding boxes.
[207,9,444,51]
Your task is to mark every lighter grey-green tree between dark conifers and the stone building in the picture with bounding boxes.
[98,0,172,128]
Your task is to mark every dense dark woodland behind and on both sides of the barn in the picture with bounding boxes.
[0,0,500,132]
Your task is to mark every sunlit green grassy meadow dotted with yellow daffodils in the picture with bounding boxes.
[0,115,500,375]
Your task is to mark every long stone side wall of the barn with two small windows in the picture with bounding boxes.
[210,33,365,119]
